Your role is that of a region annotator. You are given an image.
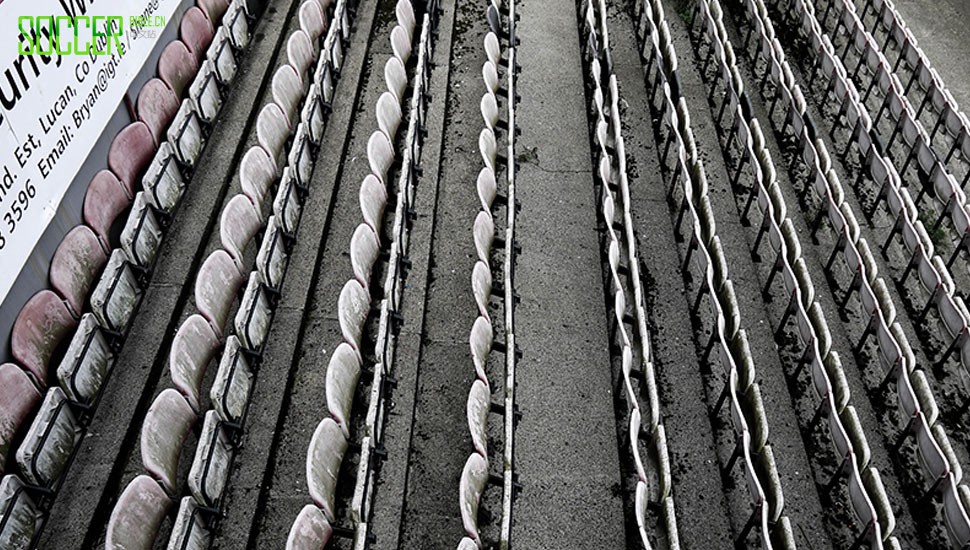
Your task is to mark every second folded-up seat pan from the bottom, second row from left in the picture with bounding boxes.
[189,411,232,508]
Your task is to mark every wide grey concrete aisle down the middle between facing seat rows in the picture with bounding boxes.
[512,0,626,548]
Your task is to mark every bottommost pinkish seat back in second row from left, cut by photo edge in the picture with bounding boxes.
[104,475,172,550]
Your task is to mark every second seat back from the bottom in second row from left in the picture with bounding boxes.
[141,388,196,495]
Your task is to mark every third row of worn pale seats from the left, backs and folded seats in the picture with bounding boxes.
[286,0,440,550]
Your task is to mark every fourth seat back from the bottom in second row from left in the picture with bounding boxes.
[195,249,244,335]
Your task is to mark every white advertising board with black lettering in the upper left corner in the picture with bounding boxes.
[0,0,180,301]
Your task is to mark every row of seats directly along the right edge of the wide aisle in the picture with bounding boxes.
[580,0,680,549]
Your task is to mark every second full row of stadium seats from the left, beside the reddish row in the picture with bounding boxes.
[105,0,360,549]
